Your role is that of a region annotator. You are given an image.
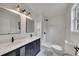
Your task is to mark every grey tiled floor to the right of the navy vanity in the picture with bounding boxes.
[37,46,72,56]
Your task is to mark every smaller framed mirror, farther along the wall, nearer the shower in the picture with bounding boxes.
[26,19,34,33]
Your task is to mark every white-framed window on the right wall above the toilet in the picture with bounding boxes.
[71,4,79,32]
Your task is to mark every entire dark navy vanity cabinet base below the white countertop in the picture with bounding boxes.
[2,38,40,56]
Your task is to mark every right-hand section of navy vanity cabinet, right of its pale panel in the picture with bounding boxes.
[25,39,40,56]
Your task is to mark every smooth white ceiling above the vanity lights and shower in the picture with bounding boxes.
[0,3,68,18]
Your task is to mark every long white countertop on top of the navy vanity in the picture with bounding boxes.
[0,36,40,55]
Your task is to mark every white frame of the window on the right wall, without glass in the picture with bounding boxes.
[71,3,79,32]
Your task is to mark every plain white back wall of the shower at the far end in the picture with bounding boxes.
[47,16,65,46]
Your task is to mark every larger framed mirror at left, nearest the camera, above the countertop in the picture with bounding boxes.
[0,7,21,35]
